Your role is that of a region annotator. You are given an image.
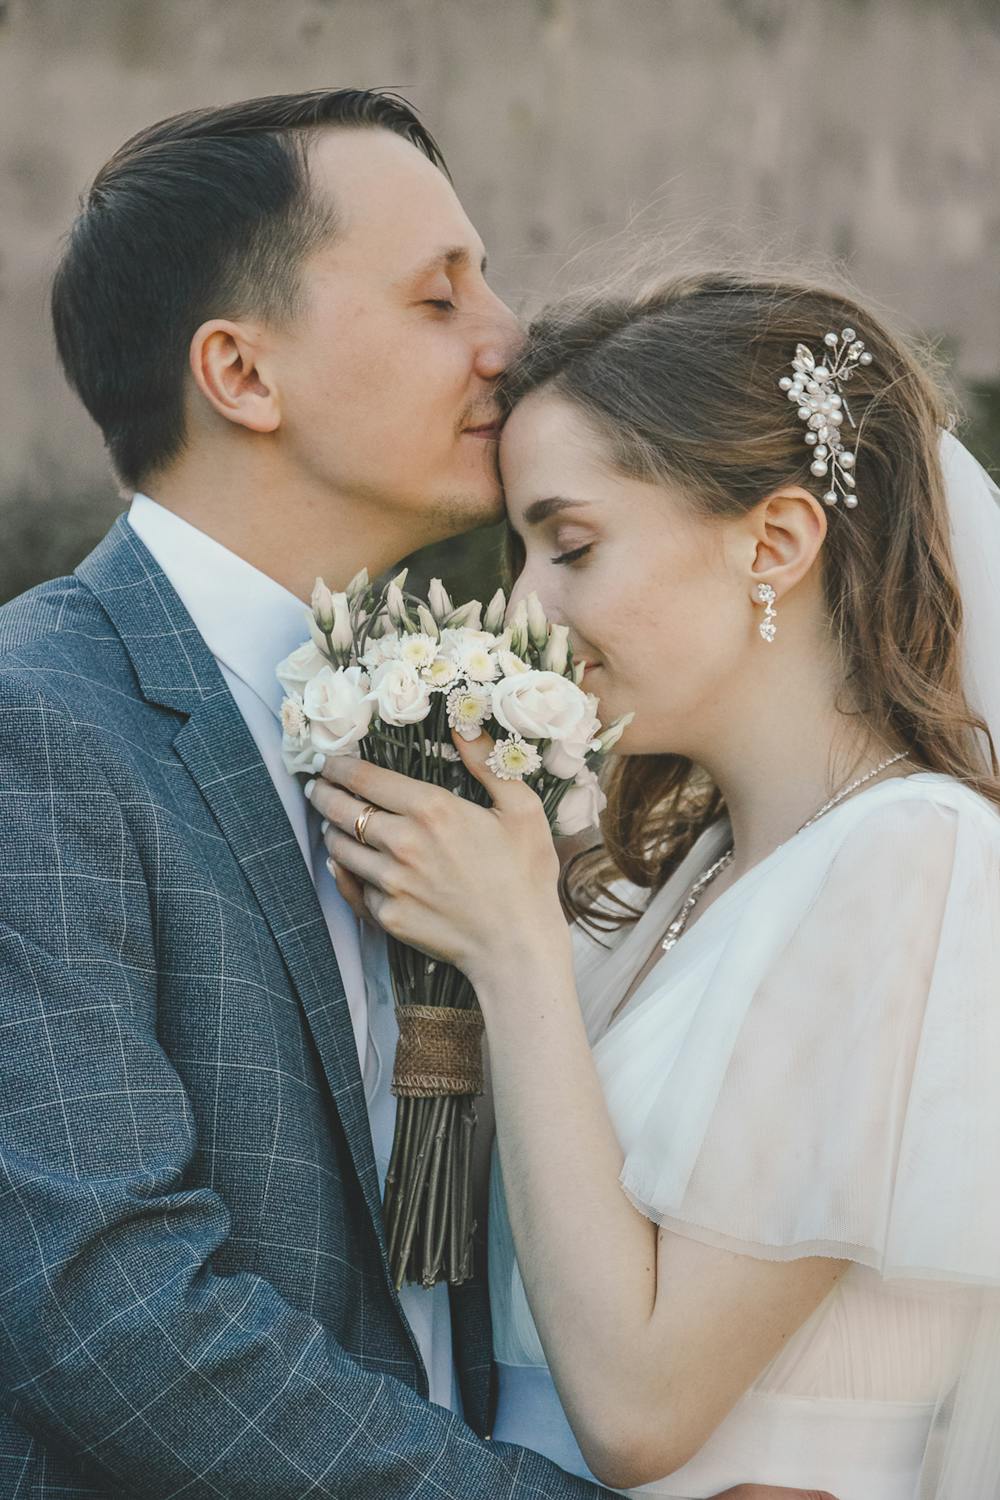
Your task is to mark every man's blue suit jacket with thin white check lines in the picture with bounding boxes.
[0,521,604,1500]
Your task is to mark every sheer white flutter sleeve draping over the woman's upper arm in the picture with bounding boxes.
[597,776,1000,1500]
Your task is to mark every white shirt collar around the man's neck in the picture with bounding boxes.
[129,494,309,717]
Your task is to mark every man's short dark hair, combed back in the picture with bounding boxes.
[52,89,447,489]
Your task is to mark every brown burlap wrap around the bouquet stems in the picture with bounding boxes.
[393,1005,483,1100]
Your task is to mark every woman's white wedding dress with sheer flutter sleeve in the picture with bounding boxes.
[489,773,1000,1500]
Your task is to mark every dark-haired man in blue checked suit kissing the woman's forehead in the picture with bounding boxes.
[0,90,839,1500]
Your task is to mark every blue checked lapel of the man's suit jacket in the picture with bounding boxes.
[76,518,385,1253]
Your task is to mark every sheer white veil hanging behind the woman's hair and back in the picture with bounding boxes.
[919,432,1000,1500]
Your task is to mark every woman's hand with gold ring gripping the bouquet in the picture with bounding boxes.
[307,734,568,986]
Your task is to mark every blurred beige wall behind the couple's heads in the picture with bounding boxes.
[0,0,1000,597]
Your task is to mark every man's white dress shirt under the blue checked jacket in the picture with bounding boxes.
[129,495,460,1412]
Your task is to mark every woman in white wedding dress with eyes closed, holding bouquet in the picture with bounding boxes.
[312,275,1000,1500]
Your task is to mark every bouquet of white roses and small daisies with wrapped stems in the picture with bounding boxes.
[277,572,631,1287]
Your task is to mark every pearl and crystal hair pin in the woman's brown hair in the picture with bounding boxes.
[778,329,871,510]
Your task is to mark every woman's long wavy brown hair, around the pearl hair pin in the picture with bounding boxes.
[504,272,1000,927]
